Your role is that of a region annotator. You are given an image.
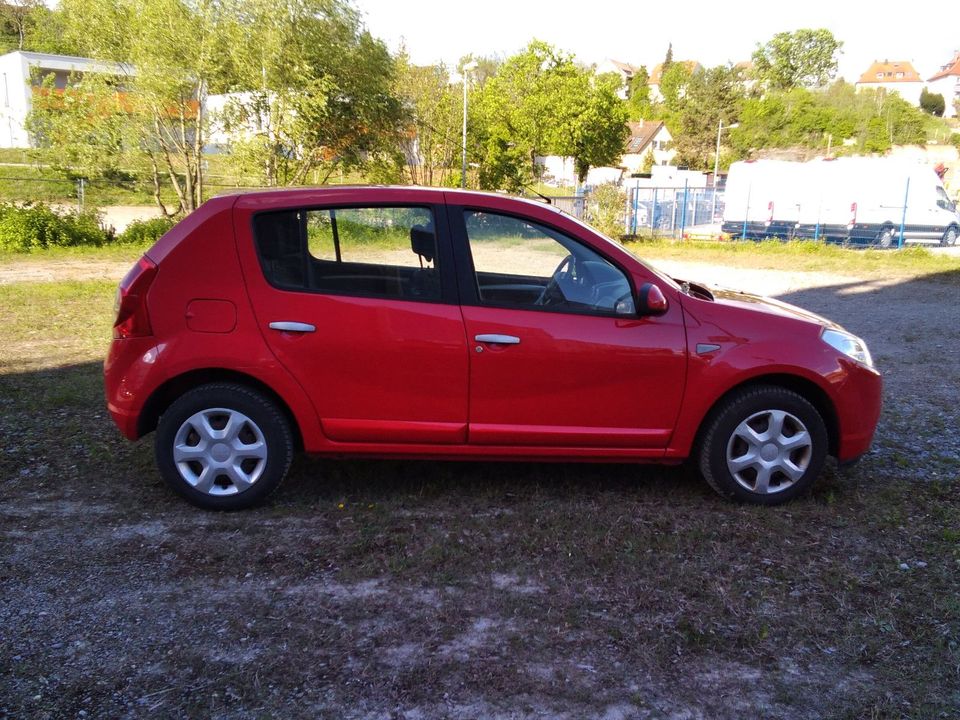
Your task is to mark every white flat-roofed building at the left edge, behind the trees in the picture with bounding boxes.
[0,50,129,148]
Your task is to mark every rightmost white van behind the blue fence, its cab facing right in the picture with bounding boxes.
[796,157,960,247]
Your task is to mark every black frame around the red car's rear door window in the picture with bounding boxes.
[250,201,459,305]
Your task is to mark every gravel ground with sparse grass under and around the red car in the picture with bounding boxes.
[0,262,960,720]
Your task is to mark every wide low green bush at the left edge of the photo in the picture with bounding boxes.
[0,203,108,252]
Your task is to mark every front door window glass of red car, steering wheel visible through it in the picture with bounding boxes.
[464,210,633,315]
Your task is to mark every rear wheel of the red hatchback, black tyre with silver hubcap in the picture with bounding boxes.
[154,383,294,510]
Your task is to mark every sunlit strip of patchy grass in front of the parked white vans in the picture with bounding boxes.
[625,240,960,276]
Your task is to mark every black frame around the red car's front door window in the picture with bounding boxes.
[447,205,639,320]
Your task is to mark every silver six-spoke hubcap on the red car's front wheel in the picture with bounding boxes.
[727,410,813,495]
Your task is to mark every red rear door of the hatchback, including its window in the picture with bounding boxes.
[235,190,467,443]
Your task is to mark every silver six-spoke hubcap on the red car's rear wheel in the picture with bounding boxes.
[173,408,267,495]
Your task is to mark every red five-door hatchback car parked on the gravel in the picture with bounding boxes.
[104,187,881,509]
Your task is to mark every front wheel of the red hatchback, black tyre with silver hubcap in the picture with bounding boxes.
[696,385,827,505]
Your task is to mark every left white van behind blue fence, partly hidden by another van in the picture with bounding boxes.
[721,160,809,240]
